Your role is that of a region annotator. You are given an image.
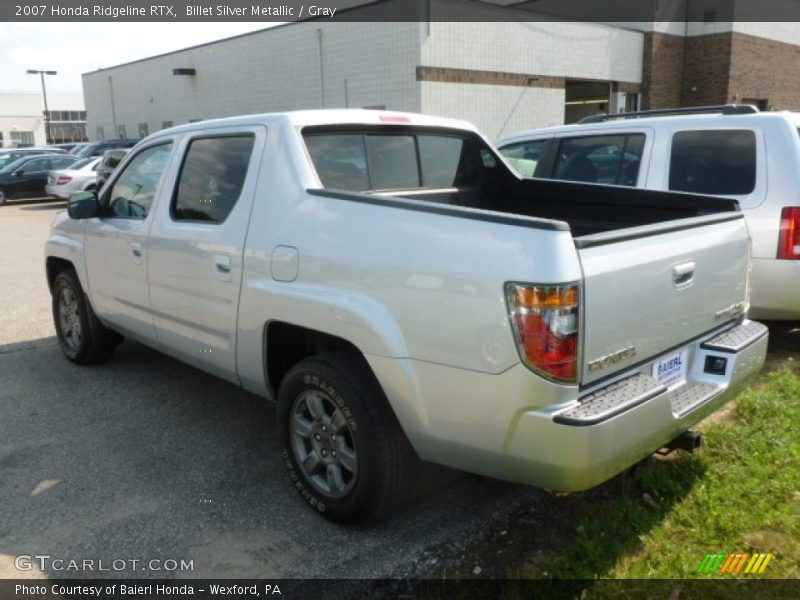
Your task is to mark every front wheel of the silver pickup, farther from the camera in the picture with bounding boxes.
[53,269,122,365]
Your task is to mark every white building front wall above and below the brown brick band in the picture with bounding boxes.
[420,22,644,139]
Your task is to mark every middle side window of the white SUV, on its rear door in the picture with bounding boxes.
[553,133,644,186]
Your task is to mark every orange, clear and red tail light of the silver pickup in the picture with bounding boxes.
[506,283,580,383]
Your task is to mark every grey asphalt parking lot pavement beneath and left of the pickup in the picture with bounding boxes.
[0,203,541,578]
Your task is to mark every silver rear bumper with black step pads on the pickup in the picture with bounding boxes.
[508,321,768,491]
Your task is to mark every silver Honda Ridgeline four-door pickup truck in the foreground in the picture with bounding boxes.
[46,110,767,522]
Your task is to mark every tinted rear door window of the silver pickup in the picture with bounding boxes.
[172,134,255,223]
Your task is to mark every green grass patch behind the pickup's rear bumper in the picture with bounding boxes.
[536,367,800,579]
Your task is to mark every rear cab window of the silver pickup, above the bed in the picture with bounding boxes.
[305,132,483,192]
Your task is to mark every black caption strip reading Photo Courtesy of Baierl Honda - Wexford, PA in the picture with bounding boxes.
[0,577,800,600]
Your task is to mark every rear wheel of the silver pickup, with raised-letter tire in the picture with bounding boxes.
[278,353,419,523]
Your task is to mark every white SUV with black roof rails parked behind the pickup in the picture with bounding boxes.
[497,105,800,320]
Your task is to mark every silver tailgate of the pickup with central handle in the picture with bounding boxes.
[575,213,750,385]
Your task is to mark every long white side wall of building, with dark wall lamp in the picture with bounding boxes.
[83,23,422,139]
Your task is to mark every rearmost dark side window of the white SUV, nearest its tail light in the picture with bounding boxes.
[669,129,756,196]
